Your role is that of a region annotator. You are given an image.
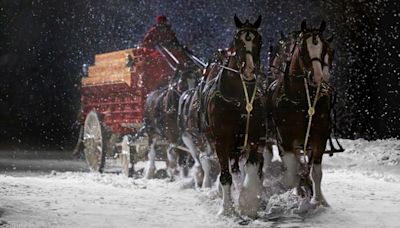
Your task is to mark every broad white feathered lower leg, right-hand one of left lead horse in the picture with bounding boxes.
[239,163,262,218]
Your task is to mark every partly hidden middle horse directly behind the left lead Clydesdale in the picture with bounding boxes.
[178,49,227,188]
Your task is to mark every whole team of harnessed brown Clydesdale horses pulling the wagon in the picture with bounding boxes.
[139,15,333,218]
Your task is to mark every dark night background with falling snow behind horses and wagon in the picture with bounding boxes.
[0,0,400,149]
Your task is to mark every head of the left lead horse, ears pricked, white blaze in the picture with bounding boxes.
[233,15,262,80]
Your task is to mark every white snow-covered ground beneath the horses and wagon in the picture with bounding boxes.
[0,140,400,228]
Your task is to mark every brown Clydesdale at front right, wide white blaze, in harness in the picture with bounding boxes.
[267,21,333,206]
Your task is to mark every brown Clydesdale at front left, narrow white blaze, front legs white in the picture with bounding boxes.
[204,15,266,218]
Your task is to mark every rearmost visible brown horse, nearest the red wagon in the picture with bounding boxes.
[143,66,200,179]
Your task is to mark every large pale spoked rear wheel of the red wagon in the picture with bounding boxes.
[83,111,106,173]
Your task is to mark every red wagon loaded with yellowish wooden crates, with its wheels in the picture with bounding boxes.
[78,47,195,176]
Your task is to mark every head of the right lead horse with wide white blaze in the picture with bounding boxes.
[296,20,333,84]
